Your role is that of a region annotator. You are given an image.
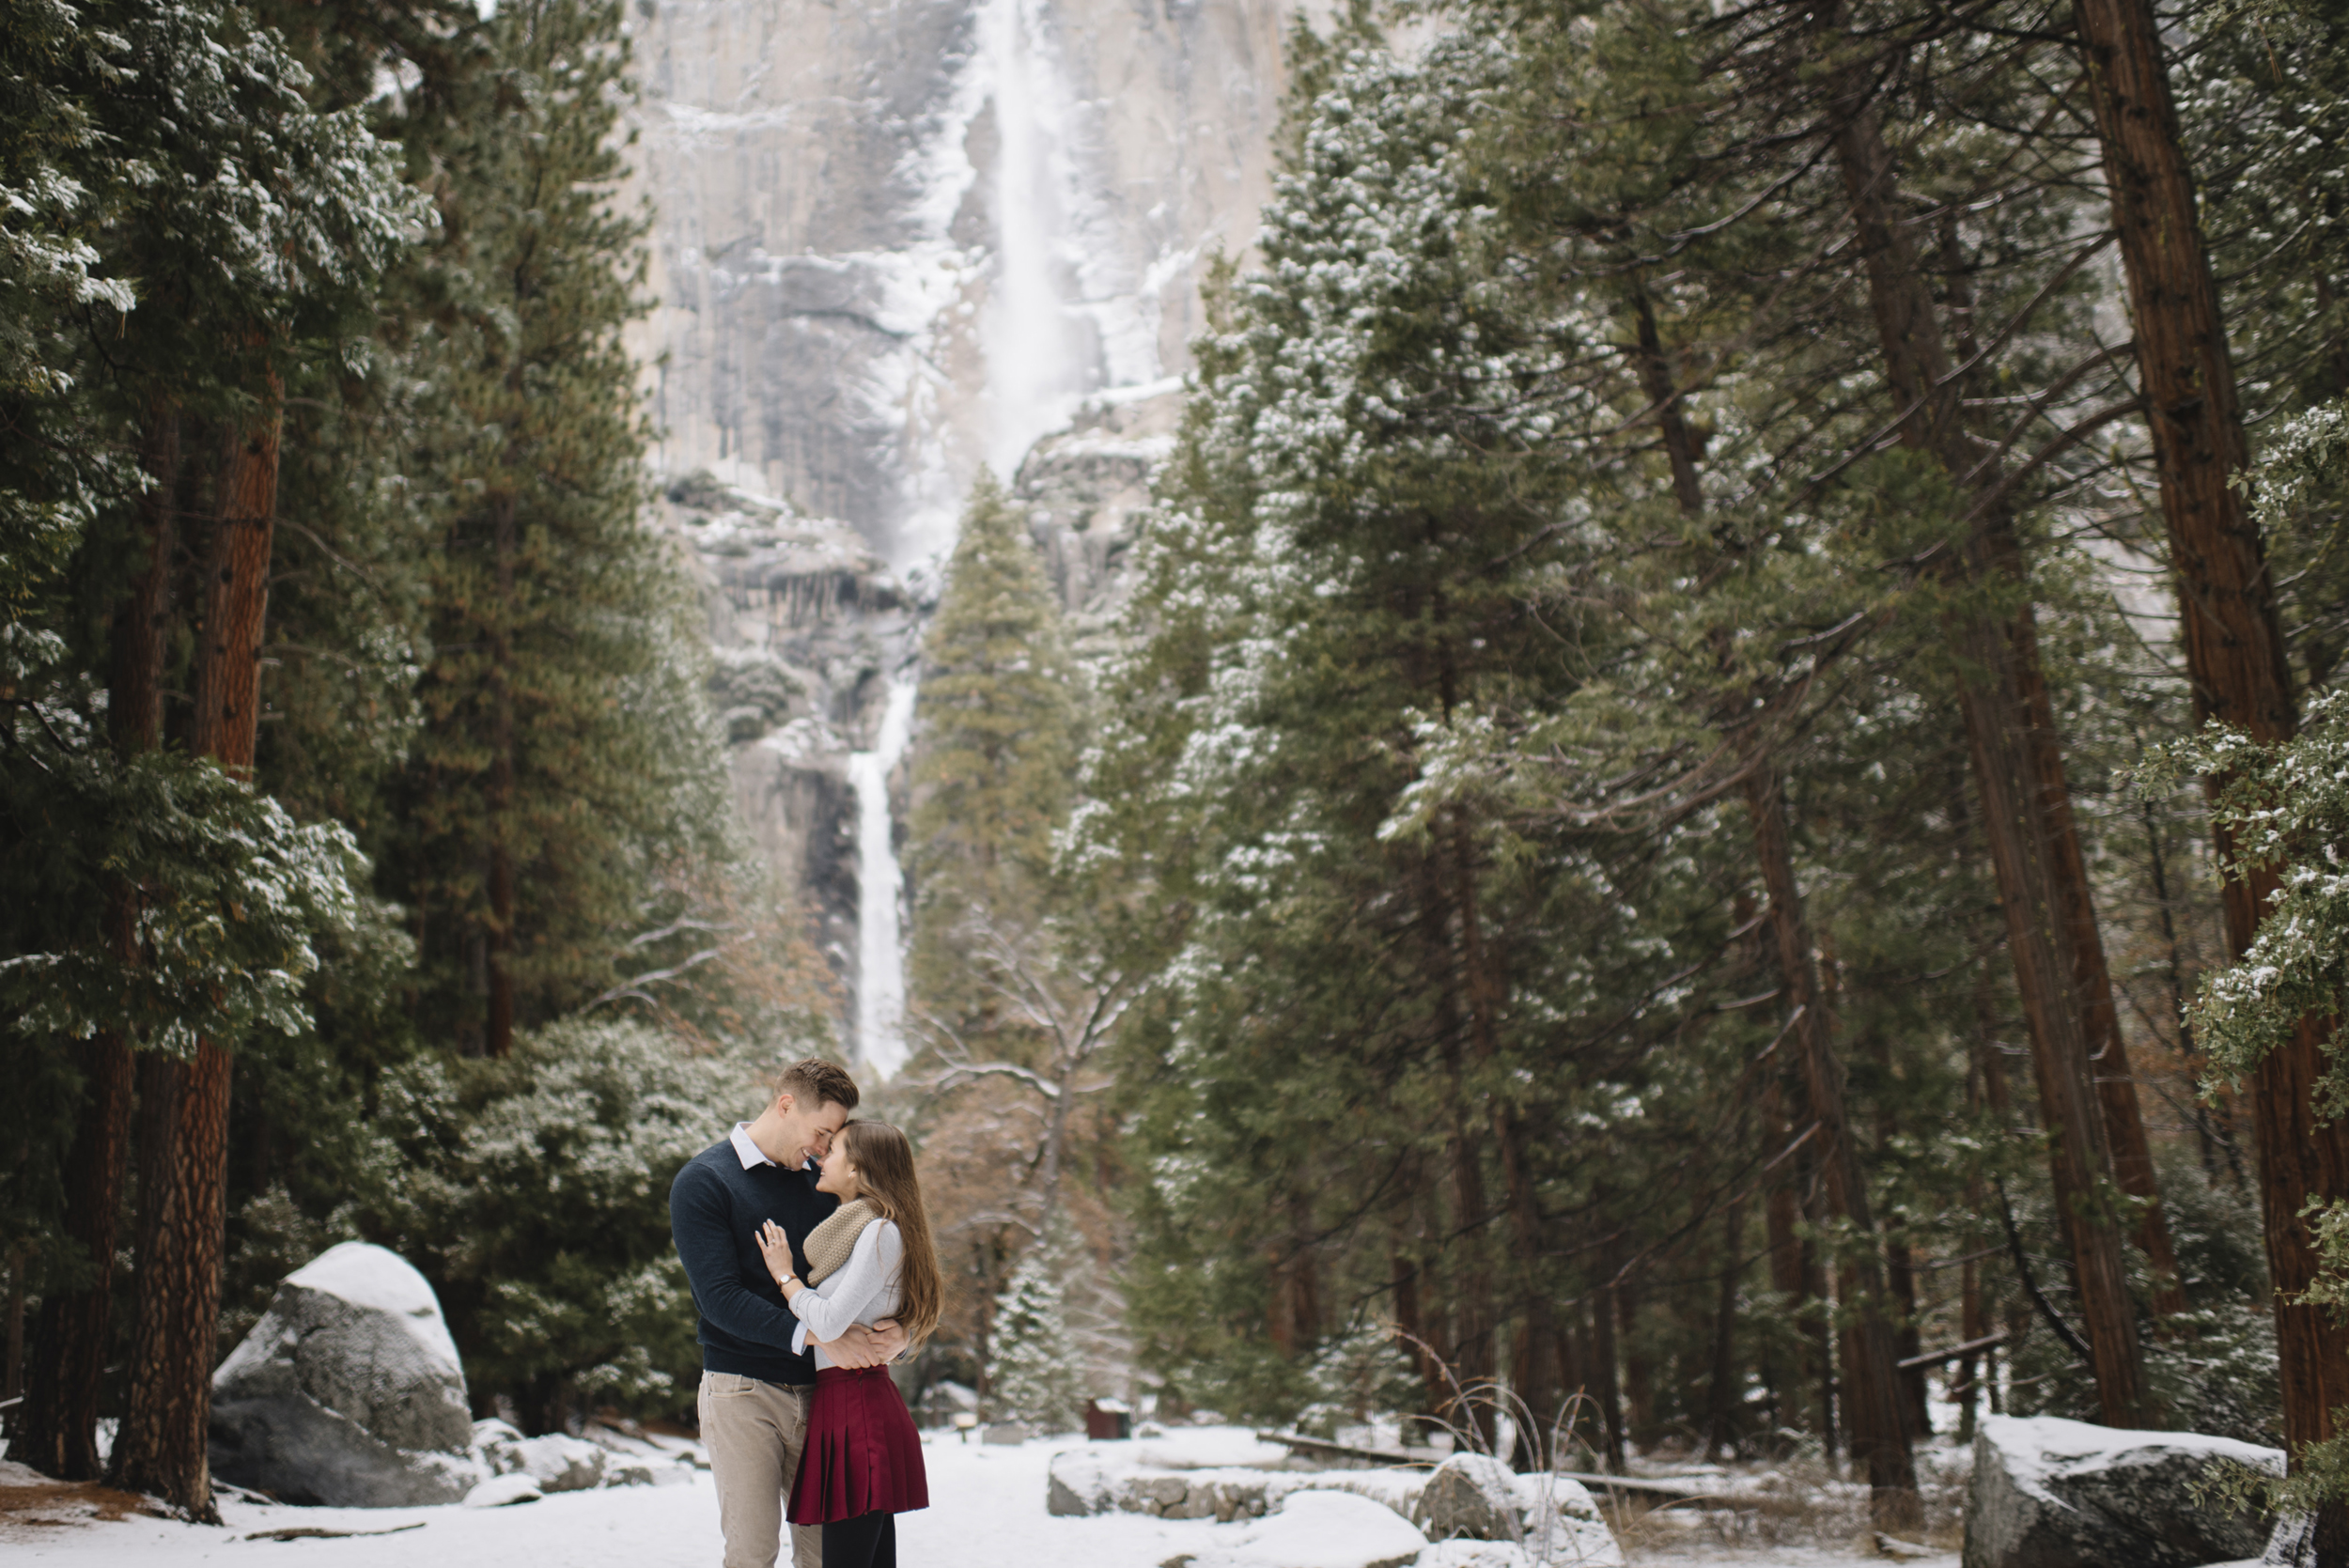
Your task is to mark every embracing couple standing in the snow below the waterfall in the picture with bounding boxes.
[670,1056,940,1568]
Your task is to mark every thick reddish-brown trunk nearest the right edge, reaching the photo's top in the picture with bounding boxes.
[2075,0,2349,1521]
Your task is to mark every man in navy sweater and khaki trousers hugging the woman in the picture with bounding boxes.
[670,1056,905,1568]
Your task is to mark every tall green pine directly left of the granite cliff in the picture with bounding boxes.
[383,0,728,1056]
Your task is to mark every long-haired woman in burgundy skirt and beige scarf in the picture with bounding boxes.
[759,1122,940,1568]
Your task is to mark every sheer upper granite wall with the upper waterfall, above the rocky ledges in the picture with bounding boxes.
[632,0,1306,566]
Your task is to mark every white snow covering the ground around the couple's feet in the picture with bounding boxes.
[0,1427,1957,1568]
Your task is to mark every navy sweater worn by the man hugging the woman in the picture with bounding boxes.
[670,1139,841,1383]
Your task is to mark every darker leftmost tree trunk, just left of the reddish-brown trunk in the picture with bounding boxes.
[9,401,179,1482]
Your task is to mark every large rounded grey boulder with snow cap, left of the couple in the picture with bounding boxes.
[211,1242,487,1507]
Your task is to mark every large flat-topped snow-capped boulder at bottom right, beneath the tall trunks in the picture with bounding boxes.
[1964,1416,2283,1568]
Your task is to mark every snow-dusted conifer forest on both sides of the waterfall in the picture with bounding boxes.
[0,0,2349,1568]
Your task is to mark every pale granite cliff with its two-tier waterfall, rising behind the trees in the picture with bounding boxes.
[632,0,1297,1056]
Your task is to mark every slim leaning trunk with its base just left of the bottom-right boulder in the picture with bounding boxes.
[1746,758,1924,1530]
